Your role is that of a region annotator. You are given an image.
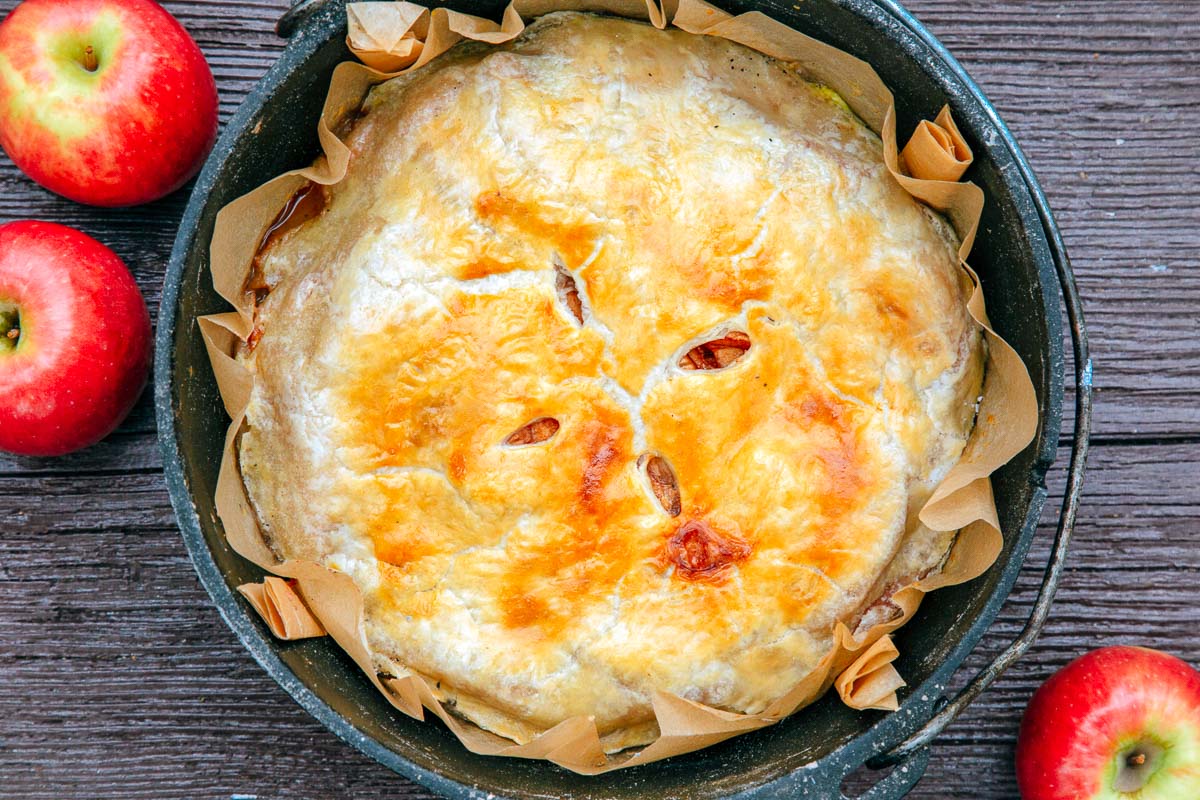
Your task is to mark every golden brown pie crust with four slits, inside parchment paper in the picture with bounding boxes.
[240,14,983,750]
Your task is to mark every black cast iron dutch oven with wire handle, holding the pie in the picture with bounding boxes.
[155,0,1091,800]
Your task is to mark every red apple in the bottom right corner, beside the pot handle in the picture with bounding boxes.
[1016,646,1200,800]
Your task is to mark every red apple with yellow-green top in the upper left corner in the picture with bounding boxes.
[0,0,217,206]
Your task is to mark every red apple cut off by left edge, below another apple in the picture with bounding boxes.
[0,222,150,456]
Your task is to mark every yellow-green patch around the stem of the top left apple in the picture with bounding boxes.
[0,12,124,142]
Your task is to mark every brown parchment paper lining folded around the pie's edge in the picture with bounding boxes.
[199,0,1038,775]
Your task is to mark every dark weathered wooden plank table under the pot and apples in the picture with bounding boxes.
[0,0,1200,800]
